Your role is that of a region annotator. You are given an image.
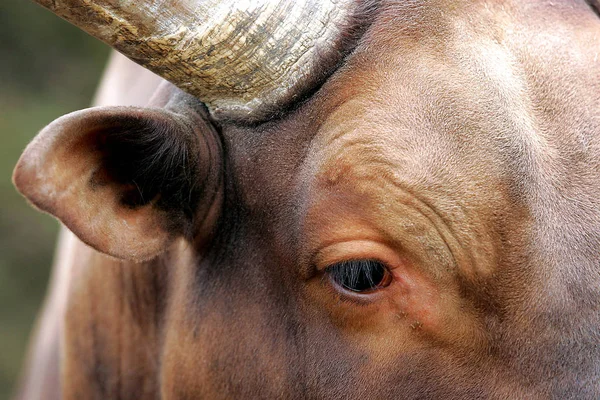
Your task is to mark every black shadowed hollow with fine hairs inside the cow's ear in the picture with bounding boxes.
[90,116,204,224]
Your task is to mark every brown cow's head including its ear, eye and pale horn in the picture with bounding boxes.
[15,0,600,399]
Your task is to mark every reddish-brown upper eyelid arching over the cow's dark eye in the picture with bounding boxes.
[314,240,402,271]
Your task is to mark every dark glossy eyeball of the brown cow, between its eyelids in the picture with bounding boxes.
[327,260,387,292]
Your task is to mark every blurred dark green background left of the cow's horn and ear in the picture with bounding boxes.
[0,0,109,399]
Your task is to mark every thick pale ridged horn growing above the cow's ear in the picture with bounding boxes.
[31,0,355,119]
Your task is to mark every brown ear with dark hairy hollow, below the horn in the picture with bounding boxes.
[13,107,221,261]
